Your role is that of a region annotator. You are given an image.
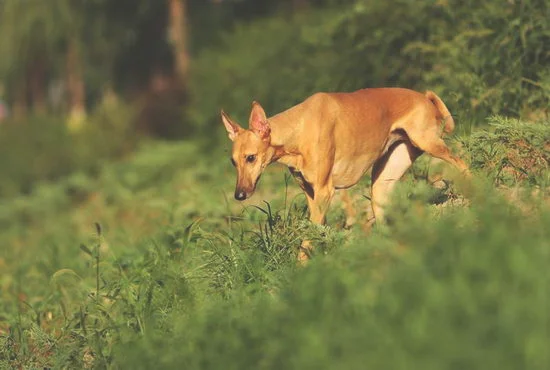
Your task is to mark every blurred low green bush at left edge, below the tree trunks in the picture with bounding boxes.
[0,101,137,198]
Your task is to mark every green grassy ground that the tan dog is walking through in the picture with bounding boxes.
[0,114,550,369]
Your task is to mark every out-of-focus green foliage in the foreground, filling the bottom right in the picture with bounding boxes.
[117,183,550,369]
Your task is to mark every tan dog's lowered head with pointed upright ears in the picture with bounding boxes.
[221,102,274,200]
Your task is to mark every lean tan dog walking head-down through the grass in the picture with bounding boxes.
[221,88,468,260]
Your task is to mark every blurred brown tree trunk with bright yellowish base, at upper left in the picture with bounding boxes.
[66,39,86,124]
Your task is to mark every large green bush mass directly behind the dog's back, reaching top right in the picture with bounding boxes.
[188,0,550,136]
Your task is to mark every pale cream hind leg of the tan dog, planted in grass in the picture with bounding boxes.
[372,141,422,222]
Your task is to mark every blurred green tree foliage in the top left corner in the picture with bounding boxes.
[0,0,85,117]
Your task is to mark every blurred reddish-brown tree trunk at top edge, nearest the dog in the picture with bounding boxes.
[168,0,189,86]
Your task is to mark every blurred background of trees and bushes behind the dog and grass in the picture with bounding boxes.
[0,0,550,197]
